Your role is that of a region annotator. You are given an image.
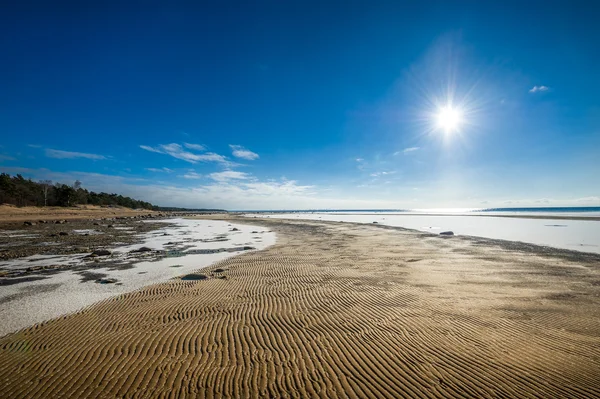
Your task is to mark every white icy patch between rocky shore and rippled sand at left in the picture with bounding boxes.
[0,219,276,336]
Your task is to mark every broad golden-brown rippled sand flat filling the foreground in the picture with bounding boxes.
[0,219,600,398]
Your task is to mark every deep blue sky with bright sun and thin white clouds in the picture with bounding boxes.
[0,0,600,210]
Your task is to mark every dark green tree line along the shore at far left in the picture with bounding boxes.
[0,173,158,209]
